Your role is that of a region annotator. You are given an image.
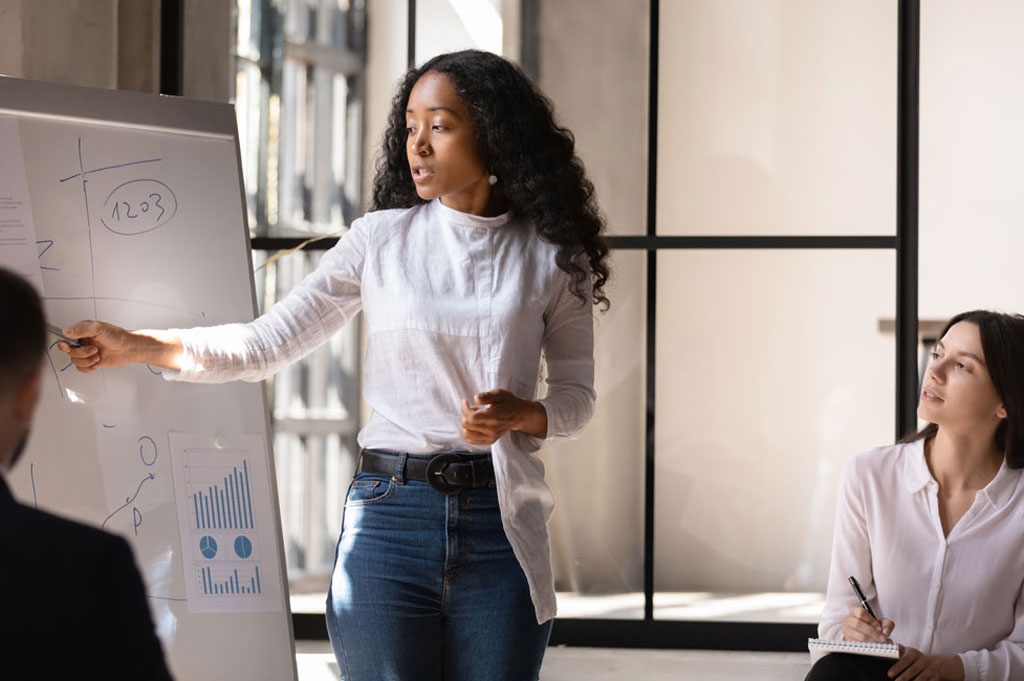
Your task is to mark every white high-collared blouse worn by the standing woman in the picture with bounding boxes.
[165,200,595,623]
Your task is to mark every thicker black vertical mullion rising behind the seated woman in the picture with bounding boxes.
[896,0,921,438]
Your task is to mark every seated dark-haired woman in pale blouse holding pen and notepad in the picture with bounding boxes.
[807,311,1024,681]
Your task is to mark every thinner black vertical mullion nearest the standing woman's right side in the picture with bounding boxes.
[643,0,660,623]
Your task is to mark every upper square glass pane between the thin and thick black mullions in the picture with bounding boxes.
[657,0,892,235]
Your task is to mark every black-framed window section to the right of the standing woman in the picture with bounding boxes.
[520,0,915,649]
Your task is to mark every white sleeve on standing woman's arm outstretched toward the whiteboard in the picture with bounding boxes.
[165,218,369,383]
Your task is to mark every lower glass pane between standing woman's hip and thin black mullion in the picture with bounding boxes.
[544,251,647,619]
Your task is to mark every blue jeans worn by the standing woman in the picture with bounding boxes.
[327,454,551,681]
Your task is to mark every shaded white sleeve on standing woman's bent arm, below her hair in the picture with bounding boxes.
[540,274,596,443]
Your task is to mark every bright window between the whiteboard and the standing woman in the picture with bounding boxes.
[236,0,365,611]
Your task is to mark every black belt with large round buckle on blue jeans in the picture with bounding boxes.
[355,450,495,495]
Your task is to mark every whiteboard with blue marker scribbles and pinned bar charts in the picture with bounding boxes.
[0,78,296,681]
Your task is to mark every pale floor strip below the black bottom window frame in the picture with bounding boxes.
[296,641,810,681]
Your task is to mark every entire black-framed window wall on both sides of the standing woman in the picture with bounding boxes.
[238,0,955,649]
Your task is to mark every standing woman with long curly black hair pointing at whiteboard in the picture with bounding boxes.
[61,50,608,681]
